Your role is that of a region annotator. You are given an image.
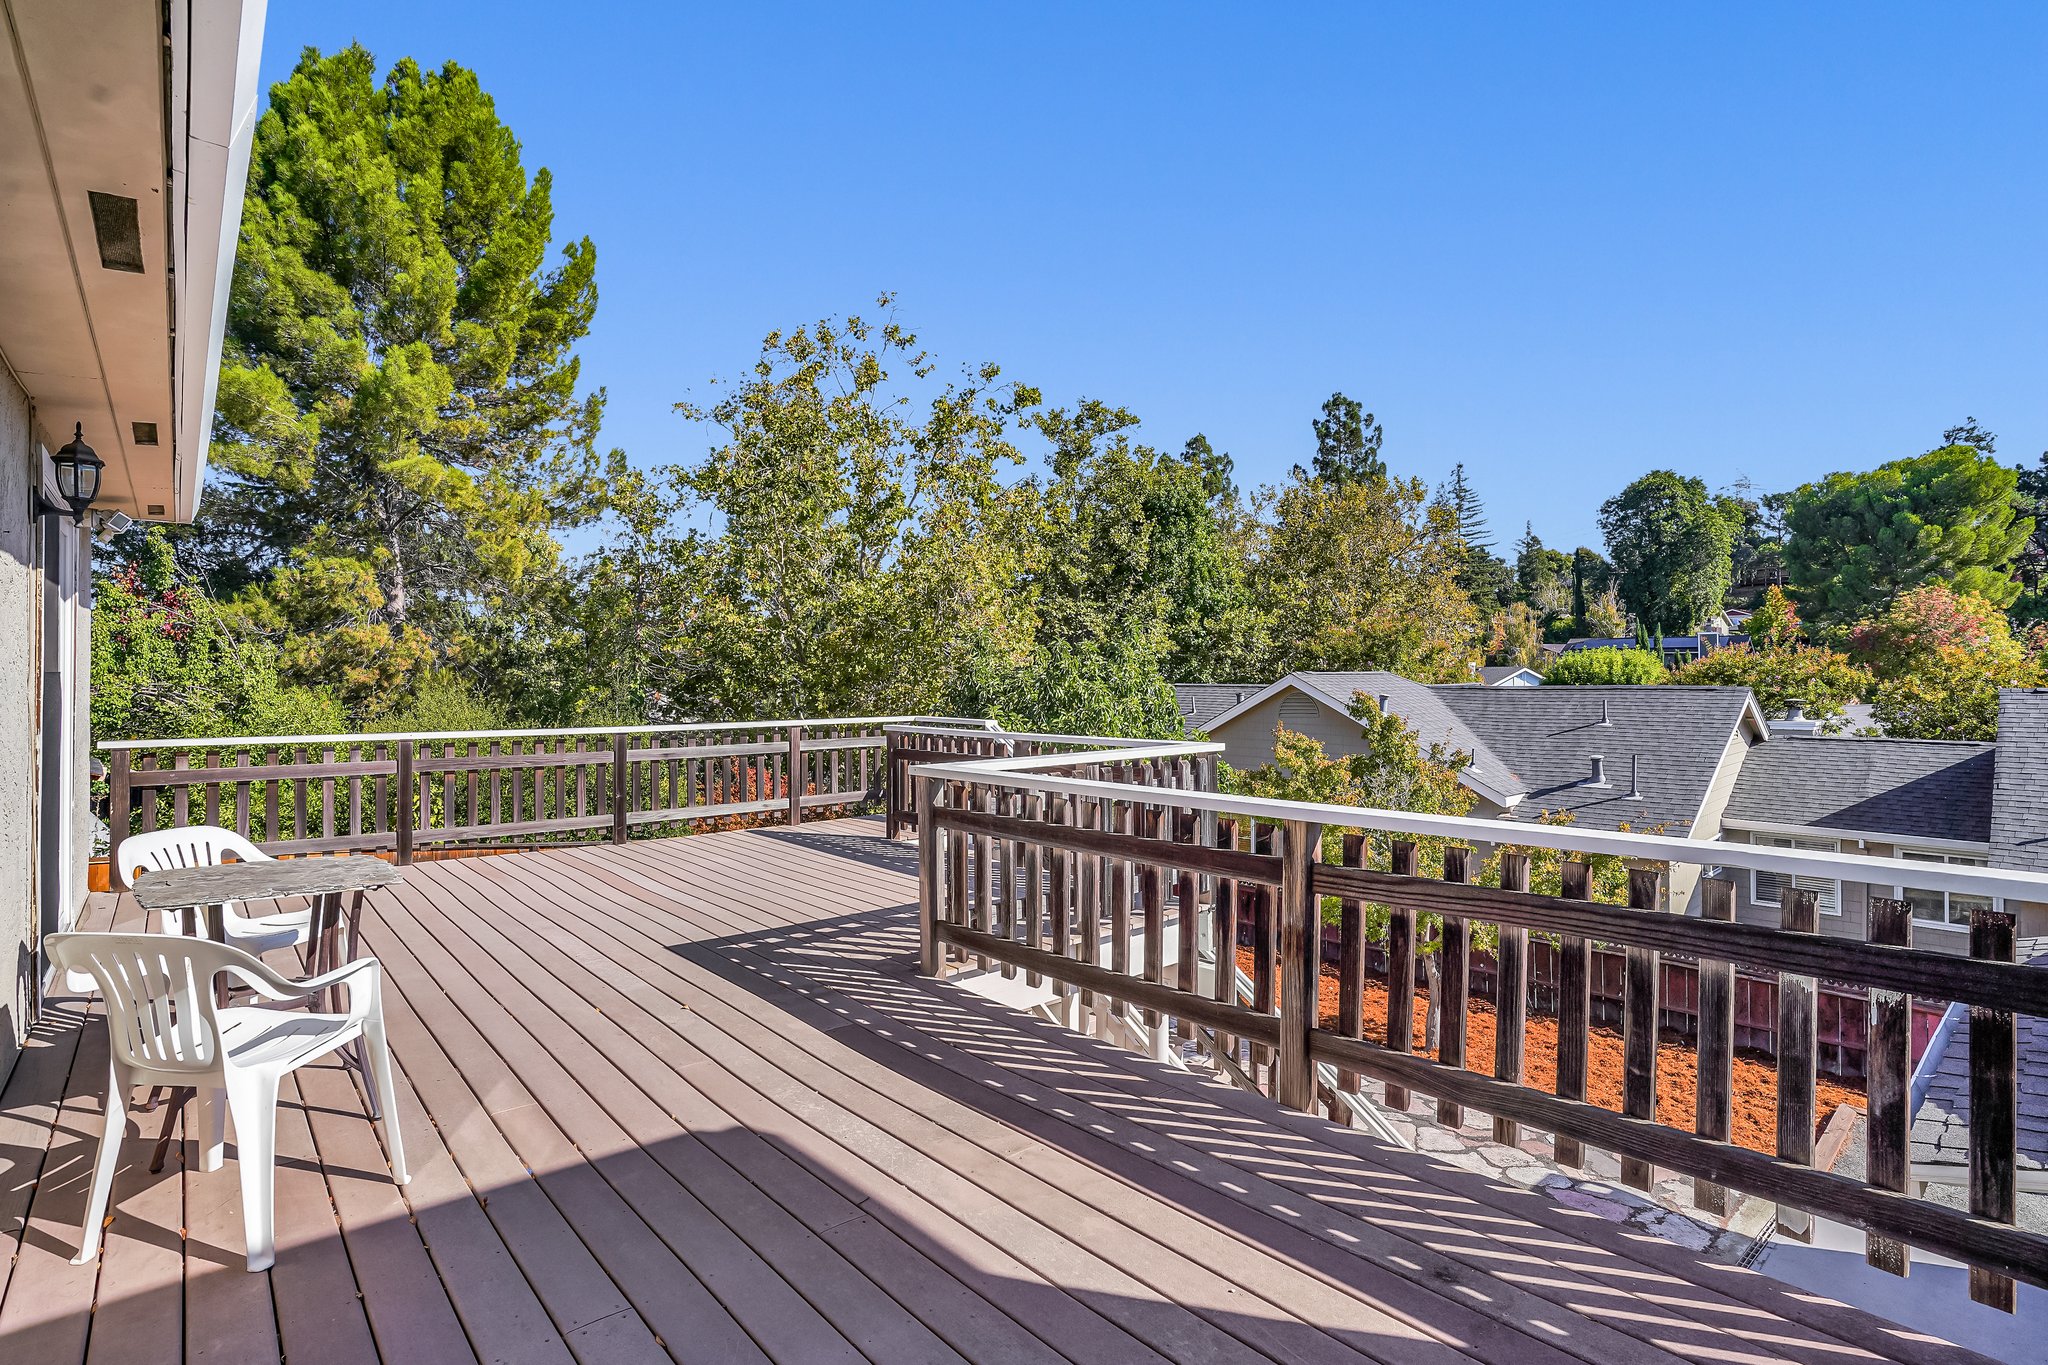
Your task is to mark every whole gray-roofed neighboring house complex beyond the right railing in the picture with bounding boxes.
[1202,673,2048,954]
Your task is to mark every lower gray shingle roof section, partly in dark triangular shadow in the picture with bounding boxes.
[1722,735,2003,839]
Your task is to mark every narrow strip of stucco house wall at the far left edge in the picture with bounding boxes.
[0,368,43,1076]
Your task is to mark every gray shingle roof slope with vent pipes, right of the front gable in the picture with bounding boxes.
[1432,686,1767,835]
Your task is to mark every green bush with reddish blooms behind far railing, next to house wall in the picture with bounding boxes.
[92,526,342,739]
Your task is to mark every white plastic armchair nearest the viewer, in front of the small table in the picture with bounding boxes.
[45,933,412,1271]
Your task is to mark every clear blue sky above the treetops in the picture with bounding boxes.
[264,0,2048,544]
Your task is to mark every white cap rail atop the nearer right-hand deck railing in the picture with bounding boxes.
[909,741,2048,902]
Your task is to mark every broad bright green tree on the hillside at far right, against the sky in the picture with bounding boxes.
[1786,444,2034,624]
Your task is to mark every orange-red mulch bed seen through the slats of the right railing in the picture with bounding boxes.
[1237,948,1864,1152]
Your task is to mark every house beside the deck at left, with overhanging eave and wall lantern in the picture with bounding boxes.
[0,0,264,1076]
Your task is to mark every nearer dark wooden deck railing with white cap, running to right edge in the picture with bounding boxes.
[911,745,2048,1310]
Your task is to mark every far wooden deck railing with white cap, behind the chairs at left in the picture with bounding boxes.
[102,716,974,884]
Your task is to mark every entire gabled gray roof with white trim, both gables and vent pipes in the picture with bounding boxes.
[1206,671,1767,835]
